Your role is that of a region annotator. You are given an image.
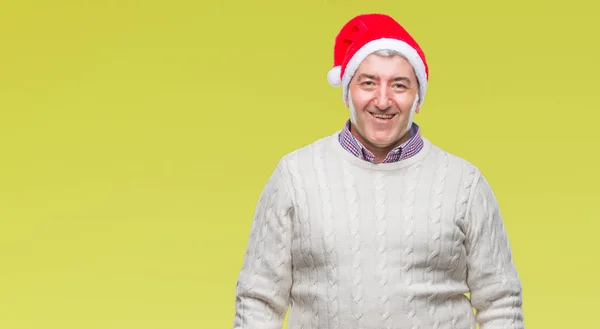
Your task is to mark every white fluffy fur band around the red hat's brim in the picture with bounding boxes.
[342,38,427,107]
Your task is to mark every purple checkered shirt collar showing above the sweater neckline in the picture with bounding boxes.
[338,120,423,163]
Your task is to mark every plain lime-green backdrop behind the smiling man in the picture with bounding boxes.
[0,0,600,329]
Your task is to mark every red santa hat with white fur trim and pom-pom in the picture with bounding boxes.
[327,14,429,107]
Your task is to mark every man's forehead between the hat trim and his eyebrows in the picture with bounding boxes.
[356,54,416,78]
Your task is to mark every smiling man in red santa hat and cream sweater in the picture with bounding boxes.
[234,14,524,329]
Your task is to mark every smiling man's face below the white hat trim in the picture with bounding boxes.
[346,54,418,149]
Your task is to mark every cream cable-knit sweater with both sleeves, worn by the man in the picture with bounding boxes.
[234,132,524,329]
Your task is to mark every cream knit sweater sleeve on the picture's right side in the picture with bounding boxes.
[465,173,525,329]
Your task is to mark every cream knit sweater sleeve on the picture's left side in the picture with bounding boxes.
[233,163,294,329]
